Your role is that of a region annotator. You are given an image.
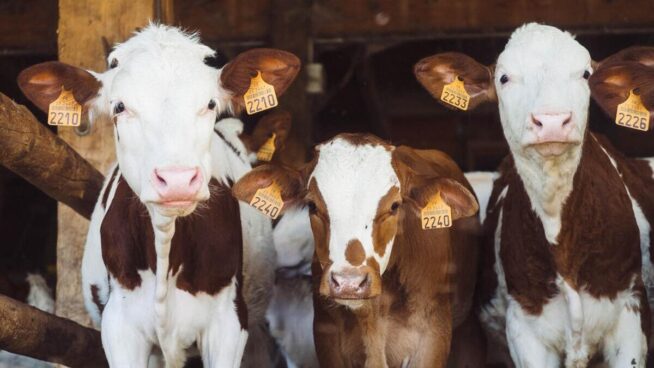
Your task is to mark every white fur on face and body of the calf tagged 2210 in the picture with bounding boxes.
[82,25,275,367]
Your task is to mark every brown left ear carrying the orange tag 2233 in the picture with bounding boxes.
[413,52,497,109]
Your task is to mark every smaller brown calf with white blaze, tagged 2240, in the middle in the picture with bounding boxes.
[233,134,482,367]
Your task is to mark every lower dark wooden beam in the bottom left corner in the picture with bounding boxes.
[0,295,108,368]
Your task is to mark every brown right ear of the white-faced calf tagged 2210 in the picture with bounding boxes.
[220,49,301,110]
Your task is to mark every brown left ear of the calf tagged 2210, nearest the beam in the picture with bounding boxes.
[18,61,102,113]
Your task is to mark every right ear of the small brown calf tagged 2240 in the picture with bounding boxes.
[408,178,479,220]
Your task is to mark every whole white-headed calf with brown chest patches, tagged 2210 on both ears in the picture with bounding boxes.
[19,25,299,367]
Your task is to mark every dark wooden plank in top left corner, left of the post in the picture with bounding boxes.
[0,0,57,54]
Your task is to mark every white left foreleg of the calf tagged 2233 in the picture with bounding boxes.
[506,303,560,368]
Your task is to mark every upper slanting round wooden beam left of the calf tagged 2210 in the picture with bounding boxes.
[0,93,104,219]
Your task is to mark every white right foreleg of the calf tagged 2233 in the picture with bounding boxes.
[604,307,647,368]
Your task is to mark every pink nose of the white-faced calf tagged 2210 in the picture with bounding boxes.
[152,167,202,202]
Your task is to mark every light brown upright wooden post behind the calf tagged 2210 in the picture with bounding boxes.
[55,0,156,325]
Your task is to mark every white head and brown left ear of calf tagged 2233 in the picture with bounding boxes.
[414,23,592,157]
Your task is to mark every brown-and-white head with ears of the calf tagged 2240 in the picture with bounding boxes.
[233,134,477,307]
